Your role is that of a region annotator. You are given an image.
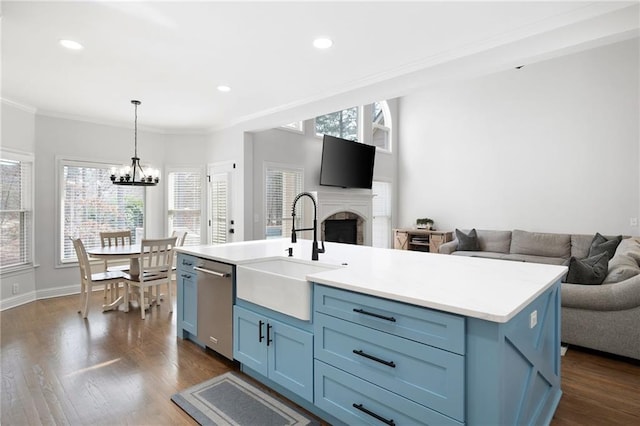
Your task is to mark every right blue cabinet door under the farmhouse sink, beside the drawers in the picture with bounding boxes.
[267,319,313,402]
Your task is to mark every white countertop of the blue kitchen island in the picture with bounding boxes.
[176,238,567,322]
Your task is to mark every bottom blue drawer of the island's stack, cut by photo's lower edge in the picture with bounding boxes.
[314,360,463,426]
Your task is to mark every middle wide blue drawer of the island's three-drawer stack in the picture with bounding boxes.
[314,314,464,421]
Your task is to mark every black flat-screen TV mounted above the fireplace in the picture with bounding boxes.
[320,135,376,189]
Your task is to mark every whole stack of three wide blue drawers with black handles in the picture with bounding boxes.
[314,285,465,425]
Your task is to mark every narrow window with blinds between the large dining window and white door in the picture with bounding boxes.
[167,169,202,246]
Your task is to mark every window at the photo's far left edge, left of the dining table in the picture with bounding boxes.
[0,152,33,271]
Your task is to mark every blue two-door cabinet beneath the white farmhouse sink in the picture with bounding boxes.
[233,305,313,401]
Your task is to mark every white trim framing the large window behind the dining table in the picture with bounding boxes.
[53,156,148,269]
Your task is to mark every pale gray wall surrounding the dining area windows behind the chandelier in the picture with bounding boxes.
[0,103,207,308]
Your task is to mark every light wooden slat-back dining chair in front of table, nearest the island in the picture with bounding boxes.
[124,237,177,319]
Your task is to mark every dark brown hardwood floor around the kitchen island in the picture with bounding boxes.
[0,292,640,426]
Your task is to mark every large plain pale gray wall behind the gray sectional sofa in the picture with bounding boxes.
[398,38,640,235]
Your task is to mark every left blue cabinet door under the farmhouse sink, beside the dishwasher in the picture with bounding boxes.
[233,306,268,376]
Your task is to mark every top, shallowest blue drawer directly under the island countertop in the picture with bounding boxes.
[313,284,465,355]
